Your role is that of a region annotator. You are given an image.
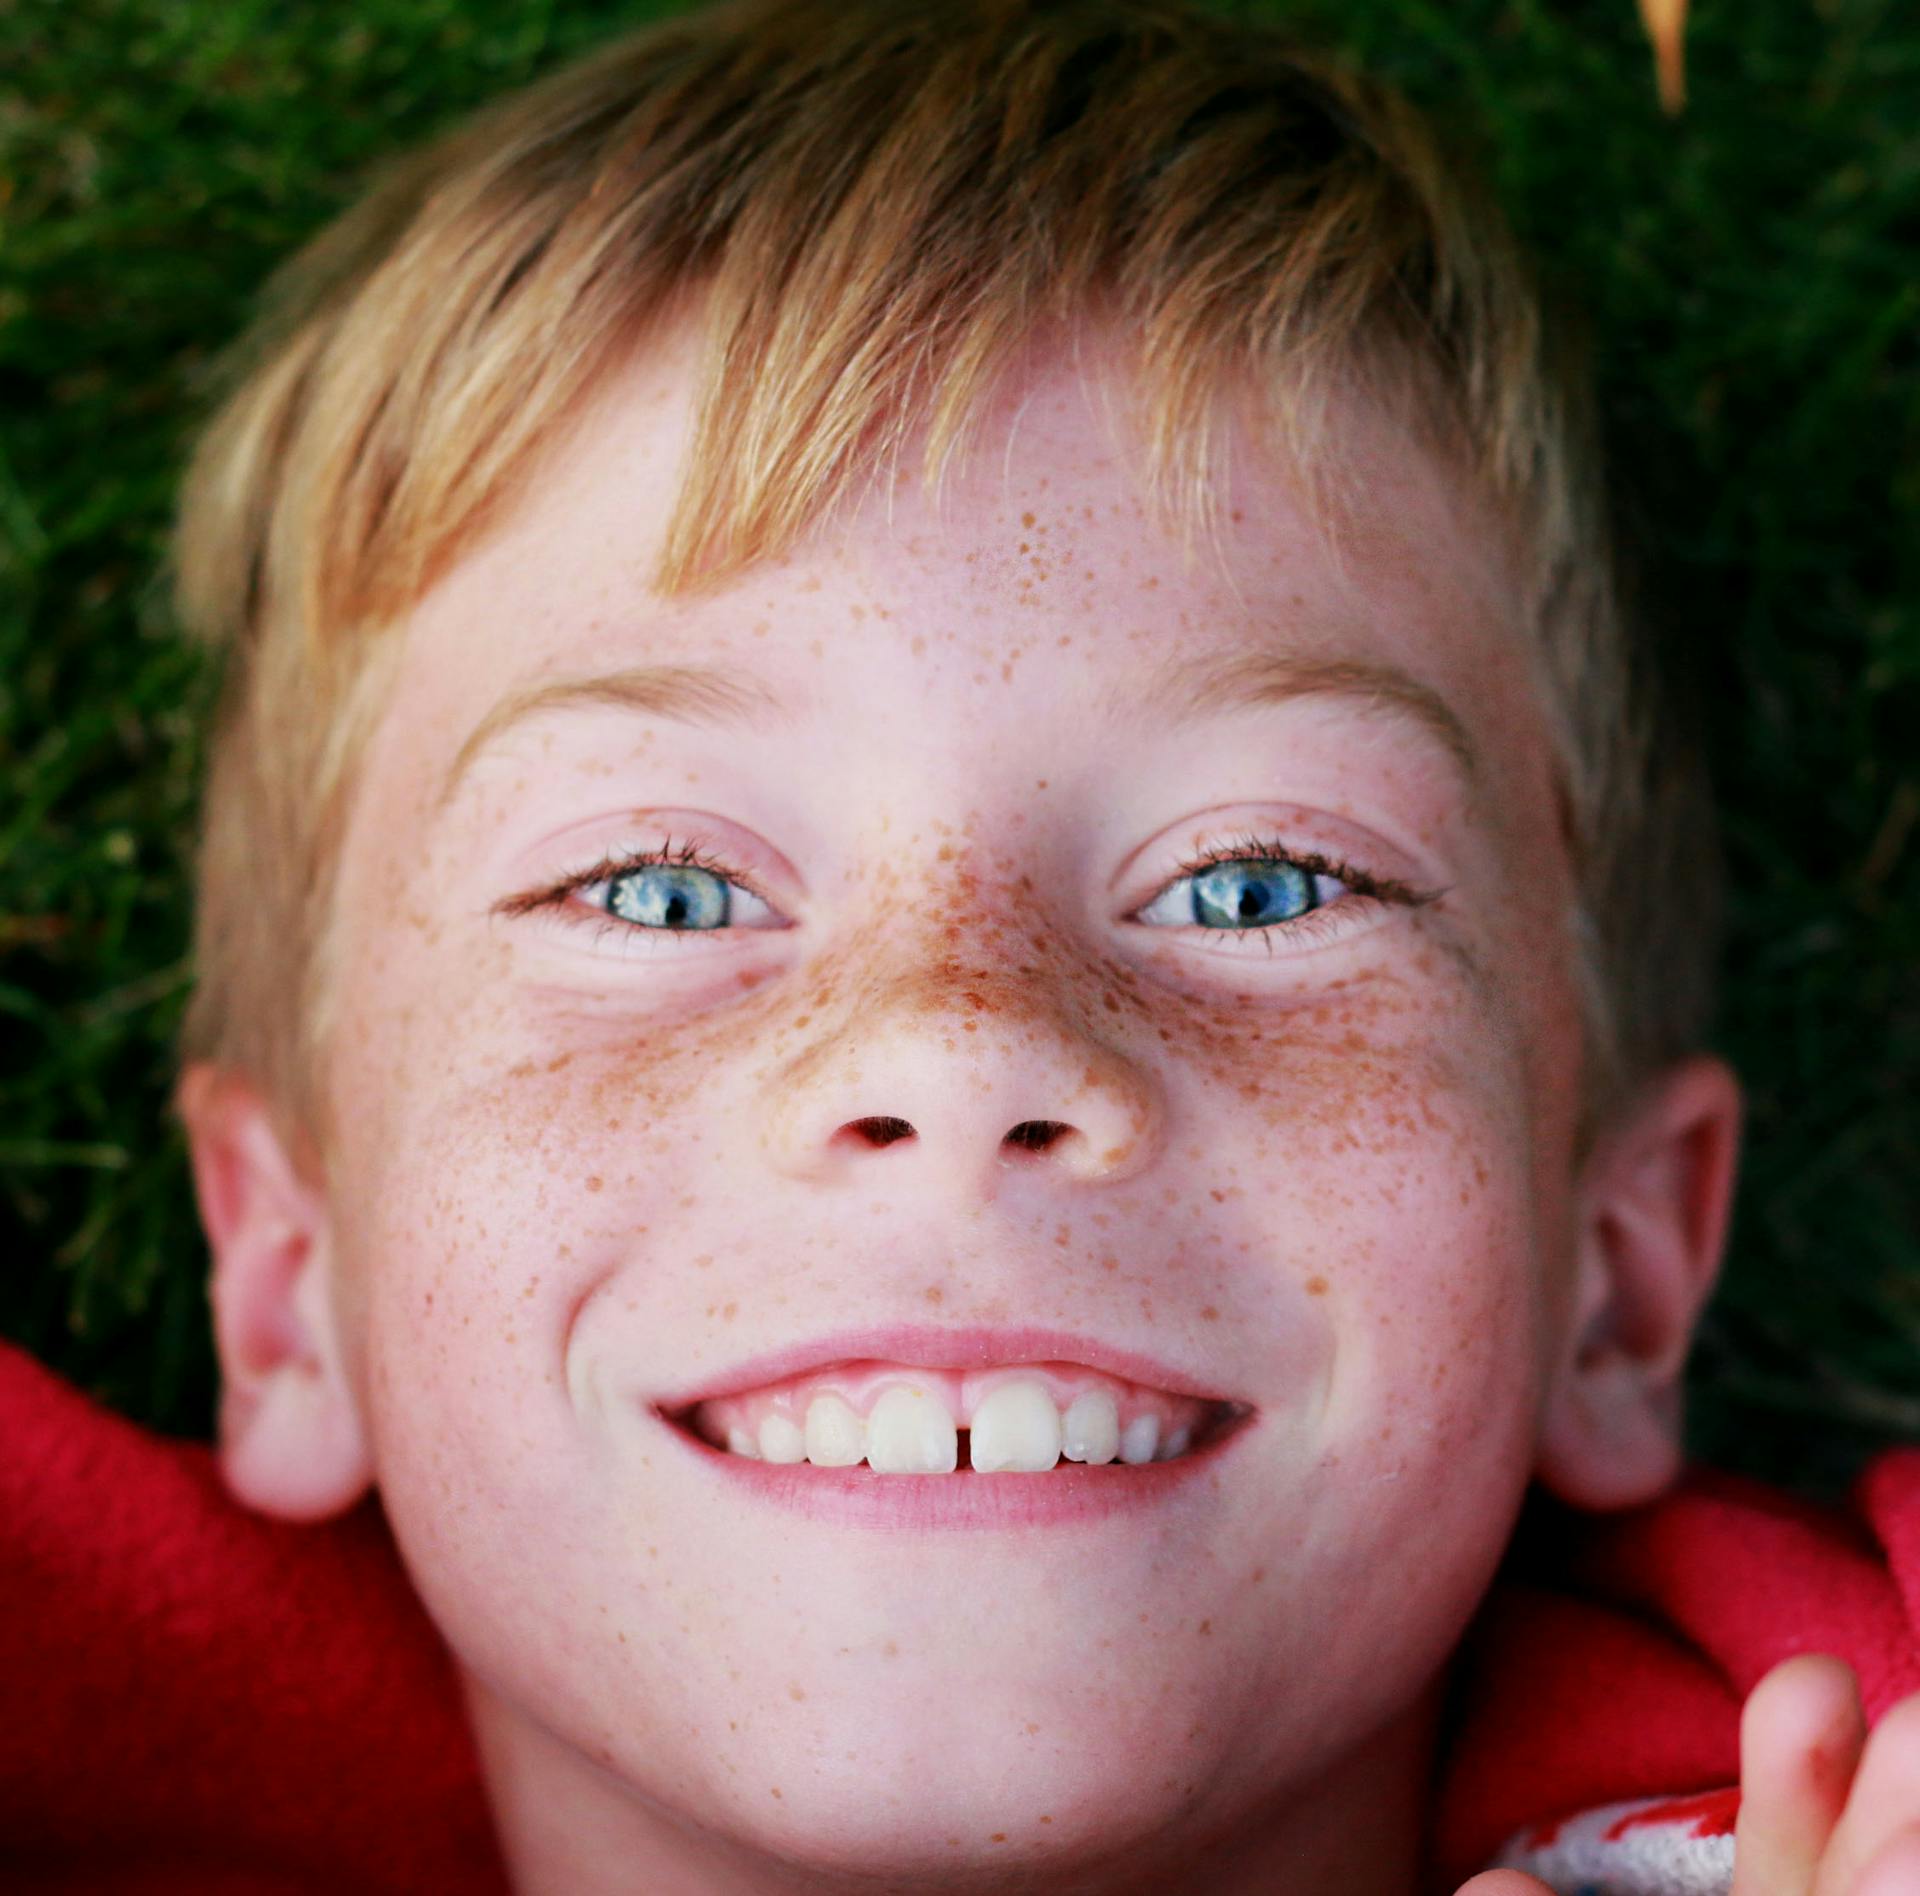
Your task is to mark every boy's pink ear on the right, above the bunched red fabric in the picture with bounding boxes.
[1536,1054,1741,1510]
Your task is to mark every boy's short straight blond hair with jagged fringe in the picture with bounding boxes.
[177,0,1713,1151]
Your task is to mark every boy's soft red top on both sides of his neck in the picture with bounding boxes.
[0,1343,1920,1896]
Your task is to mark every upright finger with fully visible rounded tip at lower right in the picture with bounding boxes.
[1732,1652,1866,1896]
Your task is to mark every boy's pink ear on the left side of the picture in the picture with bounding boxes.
[179,1065,372,1520]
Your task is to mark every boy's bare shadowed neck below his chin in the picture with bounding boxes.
[465,1675,1440,1896]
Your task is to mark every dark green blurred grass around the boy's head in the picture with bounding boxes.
[0,0,1920,1495]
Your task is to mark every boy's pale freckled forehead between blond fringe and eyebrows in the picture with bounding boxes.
[370,328,1542,829]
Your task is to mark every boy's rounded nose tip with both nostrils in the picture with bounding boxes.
[762,975,1162,1203]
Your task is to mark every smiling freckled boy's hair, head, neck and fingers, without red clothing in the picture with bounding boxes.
[15,0,1920,1896]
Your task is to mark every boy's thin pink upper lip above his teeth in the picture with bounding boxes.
[657,1324,1233,1412]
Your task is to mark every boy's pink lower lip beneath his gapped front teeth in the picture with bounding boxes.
[660,1414,1254,1533]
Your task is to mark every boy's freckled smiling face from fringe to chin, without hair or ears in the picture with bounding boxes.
[311,338,1578,1873]
